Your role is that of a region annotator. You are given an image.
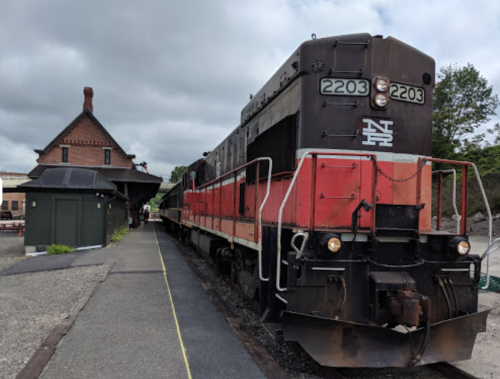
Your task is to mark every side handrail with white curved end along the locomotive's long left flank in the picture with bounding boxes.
[189,157,273,282]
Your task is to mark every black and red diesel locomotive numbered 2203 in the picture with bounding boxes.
[160,34,496,367]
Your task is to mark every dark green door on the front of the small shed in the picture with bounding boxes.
[55,199,80,246]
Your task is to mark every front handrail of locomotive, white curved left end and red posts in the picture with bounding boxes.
[276,150,377,292]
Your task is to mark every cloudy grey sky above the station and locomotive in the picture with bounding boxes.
[0,0,500,178]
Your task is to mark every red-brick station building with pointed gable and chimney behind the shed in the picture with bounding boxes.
[28,87,163,223]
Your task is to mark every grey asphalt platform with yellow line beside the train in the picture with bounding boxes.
[35,222,265,379]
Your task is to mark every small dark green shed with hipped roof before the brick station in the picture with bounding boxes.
[18,167,128,253]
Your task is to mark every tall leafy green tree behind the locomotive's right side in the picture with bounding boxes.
[432,63,499,159]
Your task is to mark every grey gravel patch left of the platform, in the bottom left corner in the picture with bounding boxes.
[0,266,101,379]
